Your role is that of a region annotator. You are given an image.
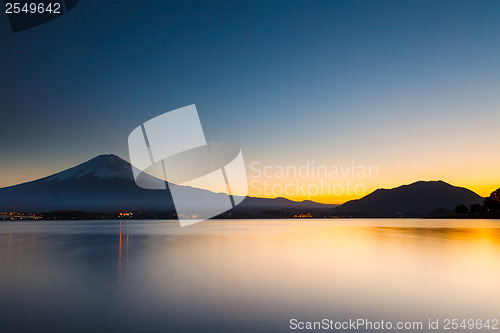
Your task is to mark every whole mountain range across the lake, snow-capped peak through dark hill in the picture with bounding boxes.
[0,155,483,217]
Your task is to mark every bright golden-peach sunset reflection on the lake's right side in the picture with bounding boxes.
[141,220,500,318]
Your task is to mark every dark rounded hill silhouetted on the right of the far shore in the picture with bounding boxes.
[335,181,483,217]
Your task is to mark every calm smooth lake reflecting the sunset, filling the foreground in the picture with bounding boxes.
[0,219,500,332]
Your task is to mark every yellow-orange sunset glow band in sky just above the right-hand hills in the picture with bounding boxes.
[247,152,500,204]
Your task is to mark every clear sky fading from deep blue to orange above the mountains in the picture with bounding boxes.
[0,0,500,203]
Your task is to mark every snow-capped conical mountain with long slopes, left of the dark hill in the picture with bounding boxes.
[0,155,334,212]
